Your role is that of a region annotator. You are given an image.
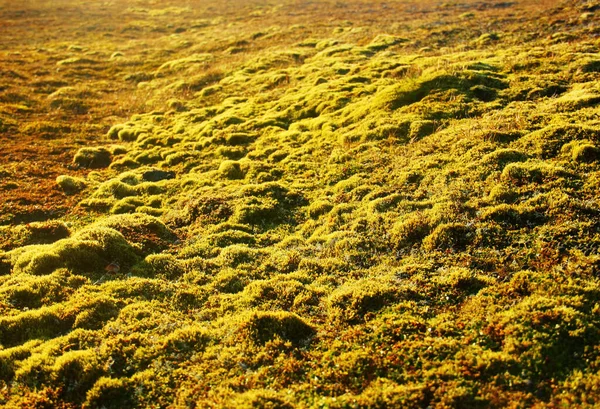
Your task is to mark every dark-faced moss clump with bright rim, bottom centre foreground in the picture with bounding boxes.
[238,311,315,345]
